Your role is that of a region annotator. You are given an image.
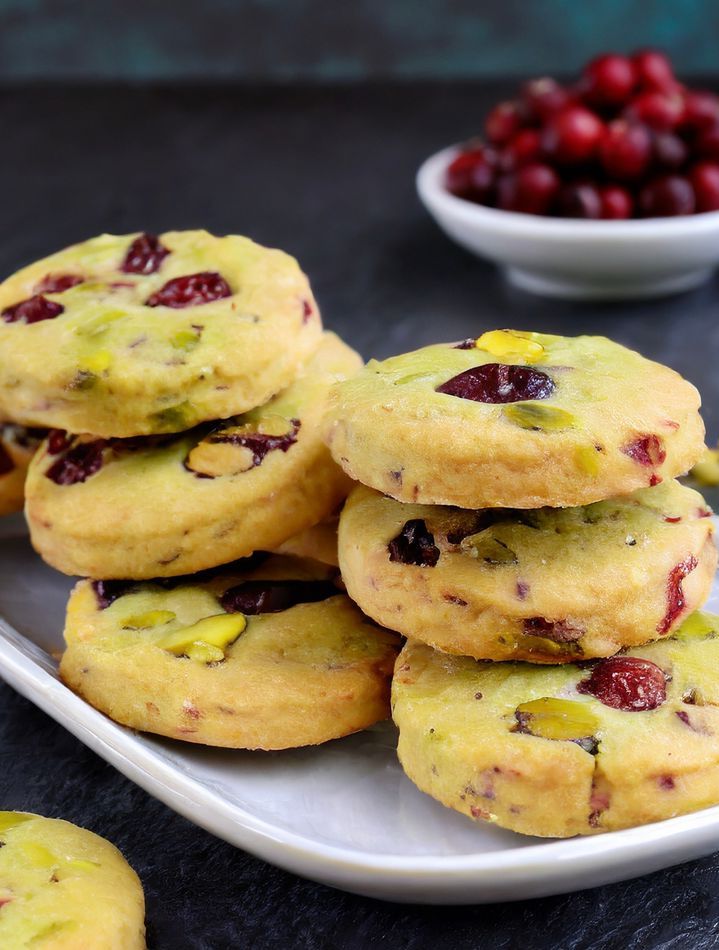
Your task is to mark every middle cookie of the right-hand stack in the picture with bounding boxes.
[338,480,717,663]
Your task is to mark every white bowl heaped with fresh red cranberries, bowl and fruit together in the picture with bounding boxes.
[417,50,719,299]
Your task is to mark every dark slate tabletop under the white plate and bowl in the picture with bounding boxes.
[0,85,719,950]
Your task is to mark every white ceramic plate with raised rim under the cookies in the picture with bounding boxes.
[0,518,719,904]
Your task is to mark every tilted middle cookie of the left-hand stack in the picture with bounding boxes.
[26,333,362,578]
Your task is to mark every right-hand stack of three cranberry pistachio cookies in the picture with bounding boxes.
[326,330,719,836]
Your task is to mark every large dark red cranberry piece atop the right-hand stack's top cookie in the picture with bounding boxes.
[436,363,554,403]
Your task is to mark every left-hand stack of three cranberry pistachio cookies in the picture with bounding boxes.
[0,231,398,749]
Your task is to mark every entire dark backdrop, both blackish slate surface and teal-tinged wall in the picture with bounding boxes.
[0,0,719,950]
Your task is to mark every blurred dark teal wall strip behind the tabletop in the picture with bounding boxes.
[0,0,719,82]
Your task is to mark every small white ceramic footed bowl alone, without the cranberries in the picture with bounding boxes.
[417,146,719,300]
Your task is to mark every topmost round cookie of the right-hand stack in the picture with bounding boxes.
[326,330,704,508]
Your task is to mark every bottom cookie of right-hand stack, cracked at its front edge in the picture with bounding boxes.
[392,613,719,837]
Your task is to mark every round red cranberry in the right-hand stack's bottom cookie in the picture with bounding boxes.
[577,656,667,712]
